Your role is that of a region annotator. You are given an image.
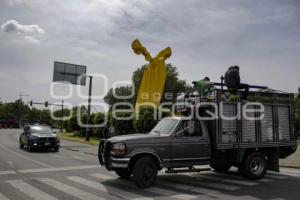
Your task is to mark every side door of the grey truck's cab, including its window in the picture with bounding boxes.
[171,120,210,164]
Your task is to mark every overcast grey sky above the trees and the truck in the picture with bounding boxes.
[0,0,300,111]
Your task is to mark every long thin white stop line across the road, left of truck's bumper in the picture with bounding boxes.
[17,165,99,174]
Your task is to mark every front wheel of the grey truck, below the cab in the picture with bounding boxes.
[133,157,157,188]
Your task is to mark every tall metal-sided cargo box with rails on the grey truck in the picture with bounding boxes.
[177,88,297,157]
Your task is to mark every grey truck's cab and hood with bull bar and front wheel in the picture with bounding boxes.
[99,117,210,188]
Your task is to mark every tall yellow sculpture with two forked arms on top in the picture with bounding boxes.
[131,39,172,107]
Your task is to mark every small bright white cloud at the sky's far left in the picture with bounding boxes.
[1,20,45,43]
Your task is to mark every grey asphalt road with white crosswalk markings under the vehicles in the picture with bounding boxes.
[0,129,300,200]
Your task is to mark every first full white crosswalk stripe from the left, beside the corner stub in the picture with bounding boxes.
[9,181,58,200]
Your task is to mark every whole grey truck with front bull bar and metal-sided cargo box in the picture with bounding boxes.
[98,89,297,188]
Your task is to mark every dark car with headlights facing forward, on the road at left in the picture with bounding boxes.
[20,125,60,151]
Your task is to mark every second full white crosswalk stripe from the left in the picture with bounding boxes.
[37,178,104,200]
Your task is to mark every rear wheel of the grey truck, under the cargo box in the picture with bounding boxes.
[239,152,267,180]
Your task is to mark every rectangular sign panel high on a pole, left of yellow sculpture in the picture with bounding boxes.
[53,61,86,85]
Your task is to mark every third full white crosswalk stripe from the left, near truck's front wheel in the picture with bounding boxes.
[67,176,151,200]
